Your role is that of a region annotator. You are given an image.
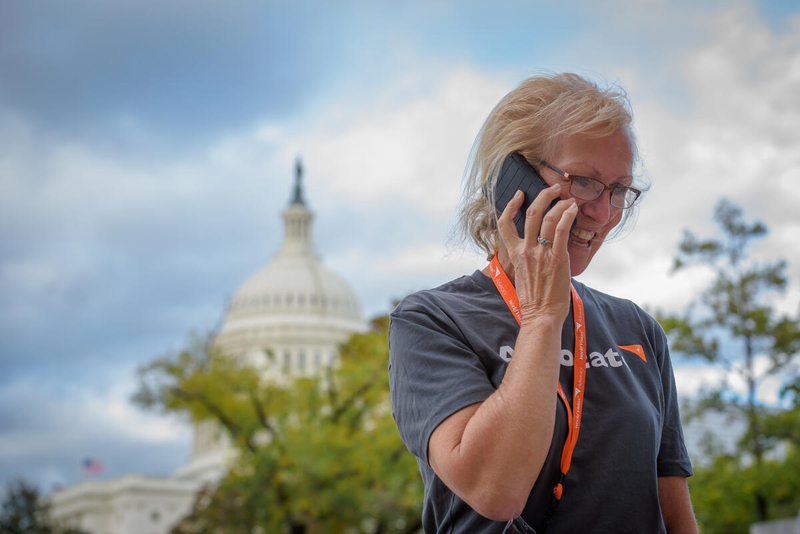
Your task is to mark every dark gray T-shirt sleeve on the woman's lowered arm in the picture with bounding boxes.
[656,326,693,477]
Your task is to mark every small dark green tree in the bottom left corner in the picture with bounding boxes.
[0,479,85,534]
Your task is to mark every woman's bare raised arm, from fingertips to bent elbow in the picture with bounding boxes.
[428,186,577,521]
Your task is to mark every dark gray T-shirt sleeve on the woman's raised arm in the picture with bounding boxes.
[389,304,495,463]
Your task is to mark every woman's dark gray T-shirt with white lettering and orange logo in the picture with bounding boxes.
[389,271,692,534]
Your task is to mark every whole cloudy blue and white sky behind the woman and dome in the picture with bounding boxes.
[0,0,800,490]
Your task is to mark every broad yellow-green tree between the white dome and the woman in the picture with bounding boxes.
[135,317,422,534]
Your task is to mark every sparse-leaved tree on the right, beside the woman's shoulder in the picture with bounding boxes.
[659,199,800,532]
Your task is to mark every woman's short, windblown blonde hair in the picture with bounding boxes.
[458,73,642,257]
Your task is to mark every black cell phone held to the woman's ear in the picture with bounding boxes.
[494,152,564,237]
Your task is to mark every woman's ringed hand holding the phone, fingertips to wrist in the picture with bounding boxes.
[498,184,578,326]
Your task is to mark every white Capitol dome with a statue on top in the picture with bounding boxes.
[177,161,367,481]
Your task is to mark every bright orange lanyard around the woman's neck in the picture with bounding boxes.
[489,256,586,501]
